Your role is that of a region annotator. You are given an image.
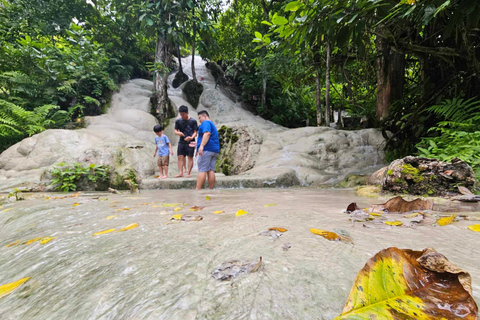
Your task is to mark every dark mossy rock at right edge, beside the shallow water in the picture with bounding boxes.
[381,156,475,196]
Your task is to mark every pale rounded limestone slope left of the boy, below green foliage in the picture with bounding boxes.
[0,79,158,190]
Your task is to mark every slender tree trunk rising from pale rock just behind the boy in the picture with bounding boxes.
[154,35,171,121]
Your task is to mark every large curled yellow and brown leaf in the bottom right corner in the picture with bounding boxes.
[335,248,478,320]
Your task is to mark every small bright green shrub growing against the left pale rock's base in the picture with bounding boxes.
[50,162,110,192]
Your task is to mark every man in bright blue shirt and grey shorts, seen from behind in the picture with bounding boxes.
[197,110,220,190]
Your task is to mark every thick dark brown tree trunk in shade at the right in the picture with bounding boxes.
[375,37,405,120]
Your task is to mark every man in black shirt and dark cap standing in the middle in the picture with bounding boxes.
[174,106,198,178]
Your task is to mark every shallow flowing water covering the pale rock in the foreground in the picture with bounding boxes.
[0,188,480,320]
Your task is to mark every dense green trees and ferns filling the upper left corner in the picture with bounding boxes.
[0,0,152,150]
